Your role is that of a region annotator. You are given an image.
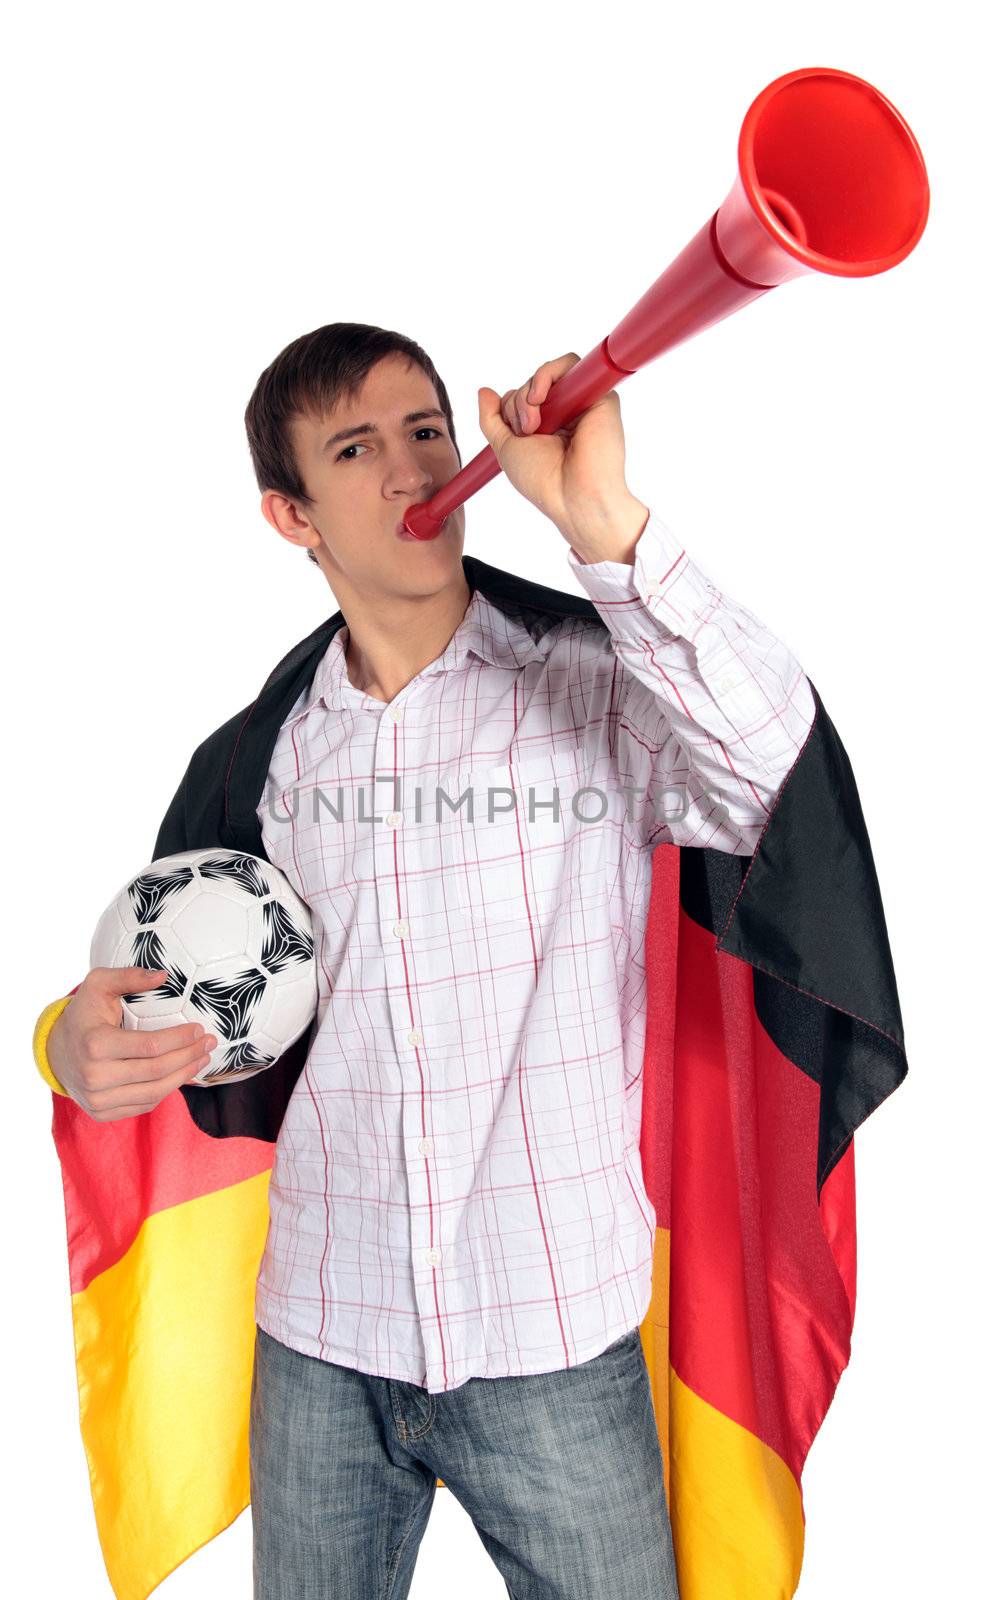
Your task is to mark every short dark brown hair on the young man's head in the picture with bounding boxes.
[245,322,461,562]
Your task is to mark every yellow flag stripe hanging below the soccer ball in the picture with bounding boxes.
[72,1171,270,1600]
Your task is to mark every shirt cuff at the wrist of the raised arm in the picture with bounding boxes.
[568,512,721,640]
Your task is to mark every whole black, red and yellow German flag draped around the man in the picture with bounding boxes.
[36,558,907,1600]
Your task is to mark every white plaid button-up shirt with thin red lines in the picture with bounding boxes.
[249,517,812,1392]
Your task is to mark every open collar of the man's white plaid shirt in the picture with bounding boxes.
[288,589,550,722]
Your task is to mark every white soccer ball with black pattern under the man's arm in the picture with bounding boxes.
[90,848,318,1083]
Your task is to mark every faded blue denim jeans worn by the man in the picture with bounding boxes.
[249,1328,678,1600]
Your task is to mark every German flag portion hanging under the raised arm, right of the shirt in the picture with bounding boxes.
[640,693,907,1600]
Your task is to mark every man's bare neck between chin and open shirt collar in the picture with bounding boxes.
[337,570,470,704]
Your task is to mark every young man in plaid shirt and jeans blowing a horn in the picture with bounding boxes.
[36,323,814,1600]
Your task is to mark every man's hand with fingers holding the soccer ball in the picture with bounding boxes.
[48,966,216,1122]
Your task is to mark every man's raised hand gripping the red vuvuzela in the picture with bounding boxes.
[478,350,649,563]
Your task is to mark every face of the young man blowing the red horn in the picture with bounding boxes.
[262,354,464,603]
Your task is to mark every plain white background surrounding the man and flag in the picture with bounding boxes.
[0,0,988,1600]
